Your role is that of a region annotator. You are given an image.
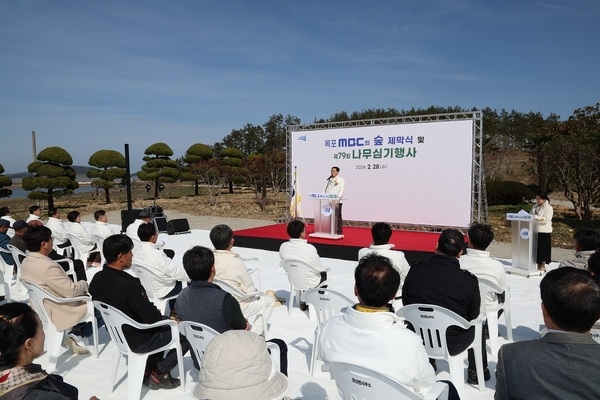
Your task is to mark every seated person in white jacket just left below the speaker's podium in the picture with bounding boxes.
[279,220,327,311]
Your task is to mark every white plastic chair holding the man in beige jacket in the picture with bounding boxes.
[23,280,98,369]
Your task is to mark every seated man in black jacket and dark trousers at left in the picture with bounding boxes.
[90,235,189,389]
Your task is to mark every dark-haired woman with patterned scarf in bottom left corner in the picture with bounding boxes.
[0,303,98,400]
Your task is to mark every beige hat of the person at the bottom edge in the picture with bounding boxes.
[193,330,289,400]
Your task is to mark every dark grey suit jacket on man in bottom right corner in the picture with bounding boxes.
[494,332,600,400]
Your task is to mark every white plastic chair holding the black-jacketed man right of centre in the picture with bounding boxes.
[396,304,485,398]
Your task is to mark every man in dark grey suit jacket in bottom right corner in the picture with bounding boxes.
[494,267,600,400]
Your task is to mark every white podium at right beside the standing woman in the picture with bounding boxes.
[506,213,542,278]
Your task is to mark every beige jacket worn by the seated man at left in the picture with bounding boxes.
[21,252,87,332]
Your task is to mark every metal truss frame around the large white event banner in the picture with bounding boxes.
[286,111,488,231]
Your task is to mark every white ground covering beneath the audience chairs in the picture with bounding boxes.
[7,230,556,400]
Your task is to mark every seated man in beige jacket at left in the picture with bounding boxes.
[21,225,91,354]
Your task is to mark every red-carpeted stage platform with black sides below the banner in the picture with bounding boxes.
[234,224,440,265]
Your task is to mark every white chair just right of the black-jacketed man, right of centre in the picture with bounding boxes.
[478,278,513,355]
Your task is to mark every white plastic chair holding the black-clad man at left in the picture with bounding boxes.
[94,300,185,400]
